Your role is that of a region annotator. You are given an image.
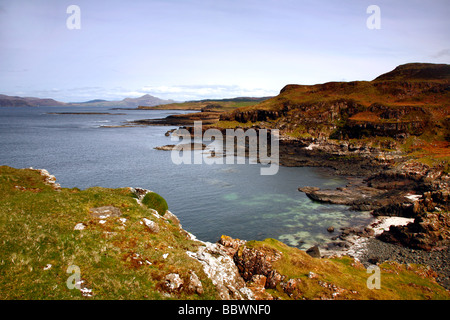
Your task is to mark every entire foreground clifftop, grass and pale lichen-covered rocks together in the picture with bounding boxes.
[0,166,450,300]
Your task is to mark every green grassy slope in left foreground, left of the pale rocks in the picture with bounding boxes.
[0,166,217,299]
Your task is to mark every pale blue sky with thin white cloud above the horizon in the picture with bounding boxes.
[0,0,450,102]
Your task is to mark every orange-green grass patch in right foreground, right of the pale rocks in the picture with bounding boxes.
[243,239,450,300]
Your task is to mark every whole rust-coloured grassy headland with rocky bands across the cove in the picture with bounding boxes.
[215,63,450,166]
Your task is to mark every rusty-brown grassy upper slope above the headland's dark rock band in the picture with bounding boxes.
[221,63,450,112]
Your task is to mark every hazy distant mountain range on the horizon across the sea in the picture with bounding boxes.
[0,94,175,108]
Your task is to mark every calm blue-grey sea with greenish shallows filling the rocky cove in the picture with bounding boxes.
[0,107,371,249]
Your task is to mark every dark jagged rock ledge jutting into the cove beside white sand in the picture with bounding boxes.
[299,163,450,251]
